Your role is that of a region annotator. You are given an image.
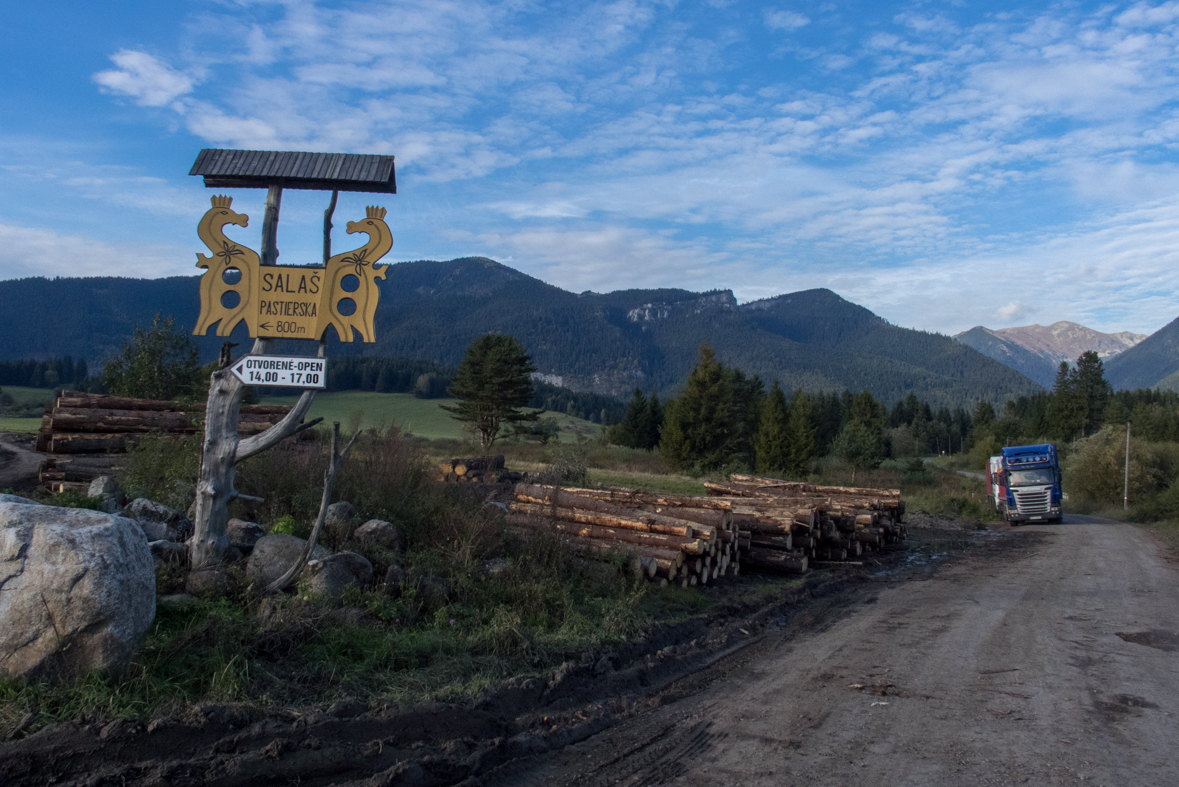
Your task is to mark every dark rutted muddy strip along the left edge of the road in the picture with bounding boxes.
[0,518,970,787]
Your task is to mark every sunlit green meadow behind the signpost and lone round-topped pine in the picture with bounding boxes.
[262,391,601,442]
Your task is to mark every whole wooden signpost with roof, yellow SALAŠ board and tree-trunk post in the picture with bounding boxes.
[189,150,397,569]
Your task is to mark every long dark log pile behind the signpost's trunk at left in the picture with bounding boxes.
[37,391,290,487]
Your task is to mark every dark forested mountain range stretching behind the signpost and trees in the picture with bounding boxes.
[0,257,1040,406]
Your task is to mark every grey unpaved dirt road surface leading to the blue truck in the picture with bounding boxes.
[481,516,1179,787]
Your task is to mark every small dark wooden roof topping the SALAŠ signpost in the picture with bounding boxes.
[189,147,397,194]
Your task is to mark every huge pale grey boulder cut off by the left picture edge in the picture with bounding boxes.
[0,502,156,679]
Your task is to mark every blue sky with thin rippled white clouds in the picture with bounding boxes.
[0,0,1179,333]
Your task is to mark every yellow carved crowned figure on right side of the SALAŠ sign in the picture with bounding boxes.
[320,206,393,342]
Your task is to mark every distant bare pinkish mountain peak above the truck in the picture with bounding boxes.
[954,320,1147,388]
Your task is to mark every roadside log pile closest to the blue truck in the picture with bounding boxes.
[705,474,905,571]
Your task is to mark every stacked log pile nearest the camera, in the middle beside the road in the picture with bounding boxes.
[508,484,742,588]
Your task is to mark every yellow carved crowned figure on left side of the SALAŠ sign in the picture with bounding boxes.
[192,196,260,337]
